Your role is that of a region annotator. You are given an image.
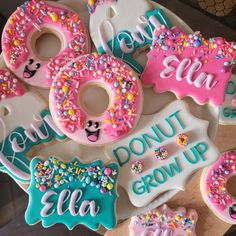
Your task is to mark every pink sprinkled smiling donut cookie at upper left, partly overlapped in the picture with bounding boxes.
[2,0,89,88]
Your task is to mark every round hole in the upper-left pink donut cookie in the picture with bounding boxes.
[34,30,62,60]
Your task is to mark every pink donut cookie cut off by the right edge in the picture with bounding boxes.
[201,151,236,224]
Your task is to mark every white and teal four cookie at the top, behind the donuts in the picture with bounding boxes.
[88,0,171,74]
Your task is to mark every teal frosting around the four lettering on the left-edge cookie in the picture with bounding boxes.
[0,109,66,183]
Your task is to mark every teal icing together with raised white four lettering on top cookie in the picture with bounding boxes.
[98,9,172,74]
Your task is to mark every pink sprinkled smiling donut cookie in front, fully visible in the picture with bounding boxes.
[49,53,142,145]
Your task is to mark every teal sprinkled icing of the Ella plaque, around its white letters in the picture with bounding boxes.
[25,157,119,230]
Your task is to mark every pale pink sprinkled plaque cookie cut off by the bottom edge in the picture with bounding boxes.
[129,205,198,236]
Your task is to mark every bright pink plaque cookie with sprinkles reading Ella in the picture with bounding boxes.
[142,26,236,106]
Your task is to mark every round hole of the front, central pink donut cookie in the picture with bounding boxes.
[78,83,111,116]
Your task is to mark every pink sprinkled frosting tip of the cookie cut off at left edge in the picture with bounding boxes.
[0,69,25,101]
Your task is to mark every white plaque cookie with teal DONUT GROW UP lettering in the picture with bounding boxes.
[105,101,219,207]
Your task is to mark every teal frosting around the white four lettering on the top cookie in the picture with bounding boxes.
[98,9,172,74]
